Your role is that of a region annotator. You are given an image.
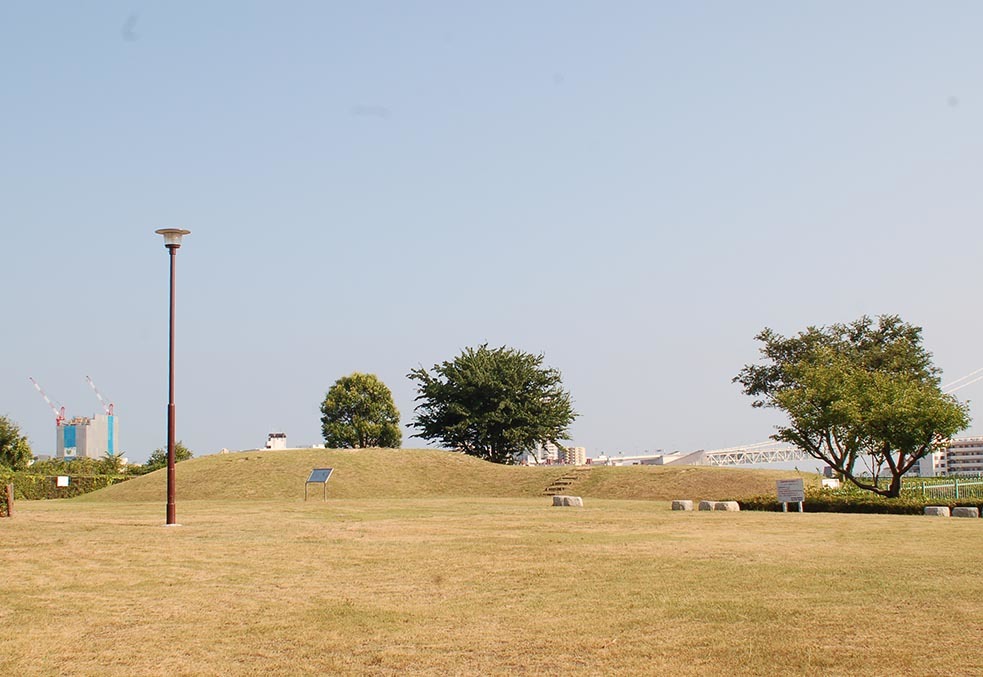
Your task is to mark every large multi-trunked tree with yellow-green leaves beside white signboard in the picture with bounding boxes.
[734,315,970,497]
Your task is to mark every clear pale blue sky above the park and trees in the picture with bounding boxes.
[0,0,983,461]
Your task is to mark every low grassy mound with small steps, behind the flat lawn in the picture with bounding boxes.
[77,449,812,502]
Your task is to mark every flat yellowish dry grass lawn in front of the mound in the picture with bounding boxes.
[0,494,983,675]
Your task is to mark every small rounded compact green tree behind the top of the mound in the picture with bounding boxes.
[321,371,403,449]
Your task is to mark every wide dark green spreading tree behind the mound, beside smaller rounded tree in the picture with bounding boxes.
[408,344,577,463]
